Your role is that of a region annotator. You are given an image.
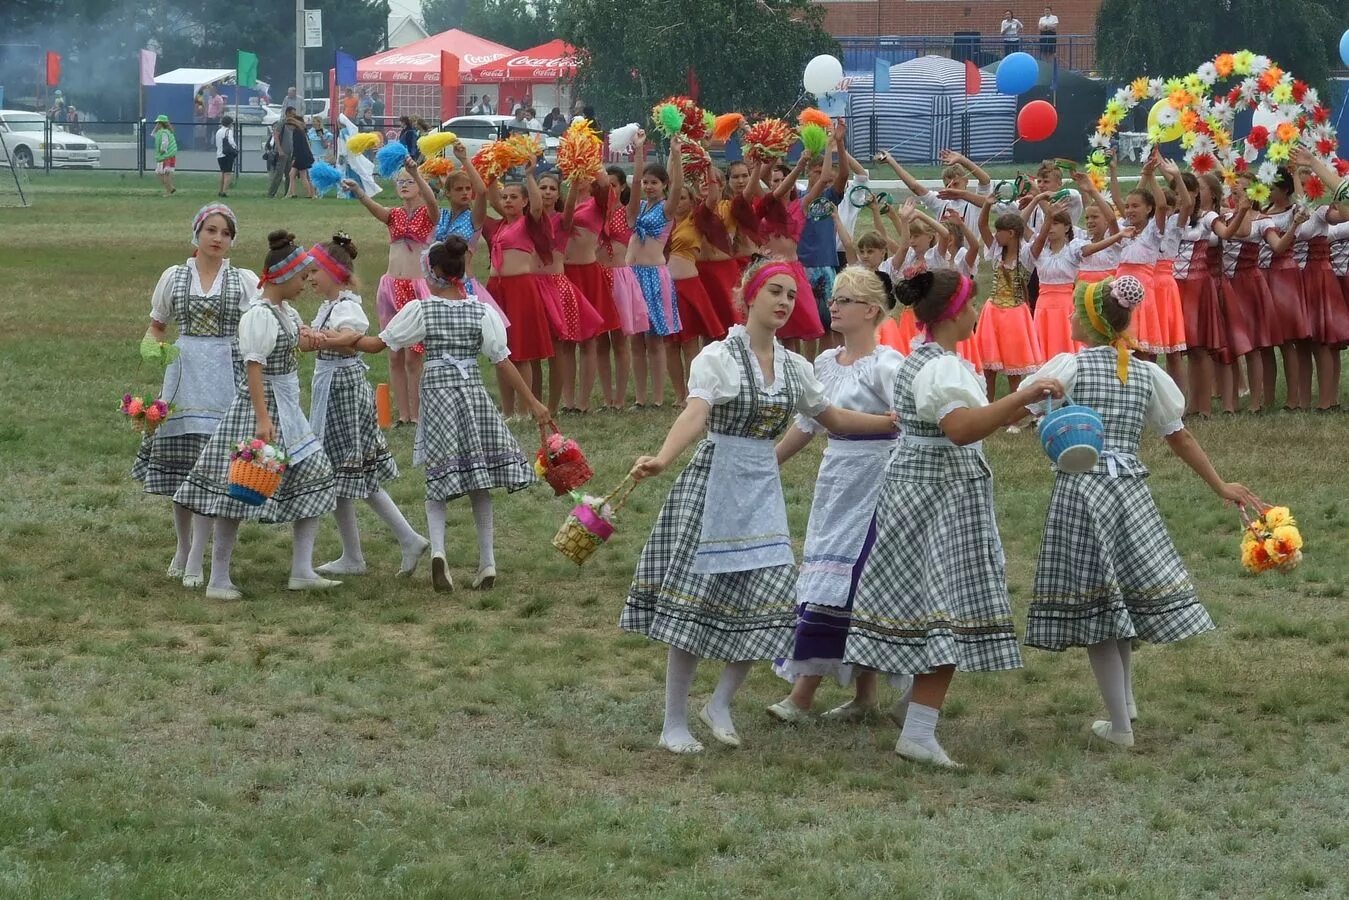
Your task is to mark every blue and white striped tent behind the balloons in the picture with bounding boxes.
[847,57,1017,163]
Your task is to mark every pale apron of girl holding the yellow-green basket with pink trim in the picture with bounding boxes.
[693,432,796,575]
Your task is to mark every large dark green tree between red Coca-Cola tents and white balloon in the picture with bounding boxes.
[558,0,838,123]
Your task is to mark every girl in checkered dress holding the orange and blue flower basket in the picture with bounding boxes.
[174,231,340,600]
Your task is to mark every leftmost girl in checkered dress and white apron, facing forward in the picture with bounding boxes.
[131,204,258,587]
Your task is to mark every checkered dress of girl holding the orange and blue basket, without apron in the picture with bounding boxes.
[173,304,337,522]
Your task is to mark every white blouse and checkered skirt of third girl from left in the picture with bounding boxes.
[309,290,398,499]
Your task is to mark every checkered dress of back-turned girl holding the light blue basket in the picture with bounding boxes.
[843,343,1021,675]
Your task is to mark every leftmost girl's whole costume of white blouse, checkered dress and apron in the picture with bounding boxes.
[131,258,258,497]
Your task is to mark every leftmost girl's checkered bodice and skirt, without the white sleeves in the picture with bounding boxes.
[131,264,246,497]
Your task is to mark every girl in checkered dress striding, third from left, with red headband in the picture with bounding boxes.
[309,235,430,576]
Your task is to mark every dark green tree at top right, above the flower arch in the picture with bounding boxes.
[1097,0,1345,86]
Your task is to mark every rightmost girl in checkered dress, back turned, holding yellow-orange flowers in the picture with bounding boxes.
[1025,275,1259,746]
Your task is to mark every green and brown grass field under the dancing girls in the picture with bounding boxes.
[0,173,1349,899]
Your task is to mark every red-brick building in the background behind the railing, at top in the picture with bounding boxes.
[816,0,1101,36]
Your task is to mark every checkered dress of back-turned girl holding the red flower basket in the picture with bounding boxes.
[413,301,537,501]
